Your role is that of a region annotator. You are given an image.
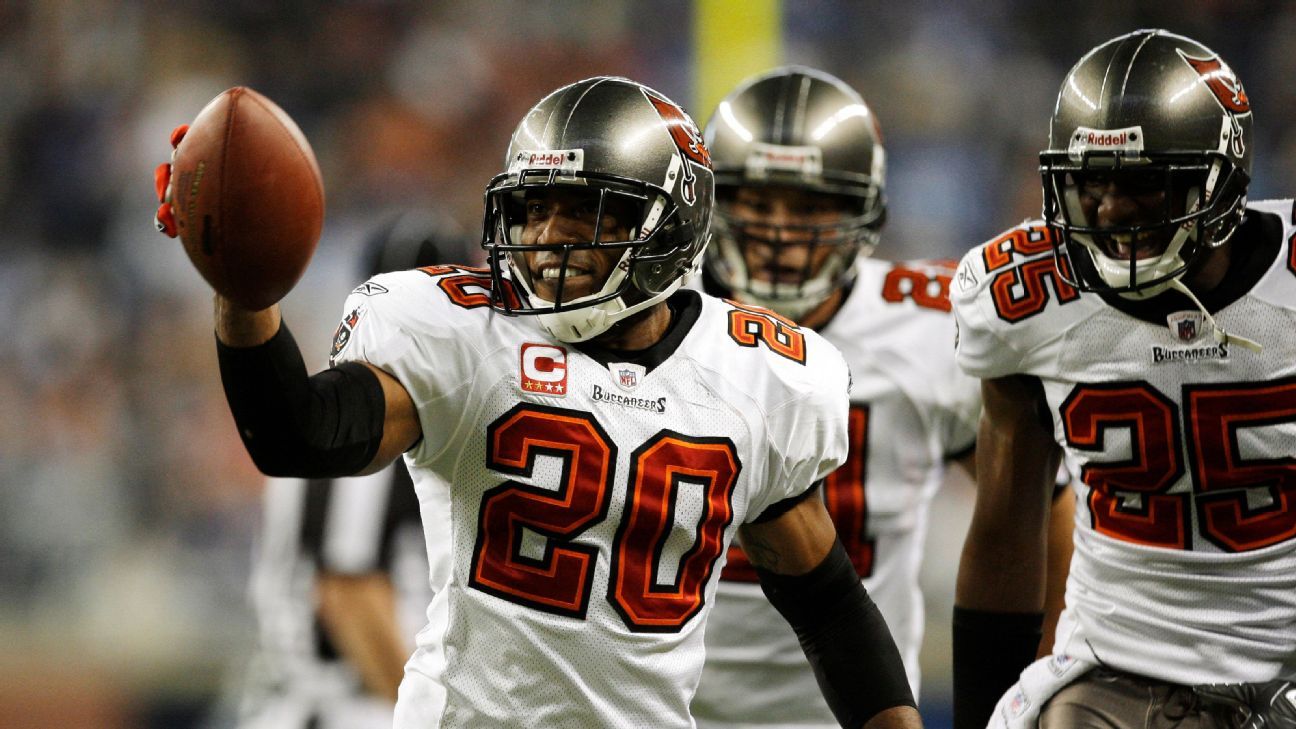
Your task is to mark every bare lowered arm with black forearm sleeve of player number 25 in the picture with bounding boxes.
[954,376,1061,729]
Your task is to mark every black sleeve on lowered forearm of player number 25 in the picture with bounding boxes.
[954,606,1045,729]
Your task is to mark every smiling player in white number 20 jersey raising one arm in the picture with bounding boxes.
[159,78,920,729]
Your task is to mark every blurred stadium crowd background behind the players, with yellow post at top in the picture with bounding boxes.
[0,0,1296,729]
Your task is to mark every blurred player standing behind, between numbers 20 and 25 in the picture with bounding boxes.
[693,66,1069,726]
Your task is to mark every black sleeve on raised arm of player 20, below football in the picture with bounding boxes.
[216,324,386,479]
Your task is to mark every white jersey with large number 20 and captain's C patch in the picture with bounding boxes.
[326,266,849,729]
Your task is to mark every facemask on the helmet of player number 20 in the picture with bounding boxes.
[482,170,682,342]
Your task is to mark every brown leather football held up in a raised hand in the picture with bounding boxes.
[171,86,324,309]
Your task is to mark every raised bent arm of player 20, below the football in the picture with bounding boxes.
[216,294,421,477]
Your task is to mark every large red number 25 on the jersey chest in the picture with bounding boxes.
[1061,379,1296,551]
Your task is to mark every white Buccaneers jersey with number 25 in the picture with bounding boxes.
[953,201,1296,684]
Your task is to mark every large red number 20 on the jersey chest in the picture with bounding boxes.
[469,403,741,632]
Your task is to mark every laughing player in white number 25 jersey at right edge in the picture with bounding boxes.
[953,30,1296,729]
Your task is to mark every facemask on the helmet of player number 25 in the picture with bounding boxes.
[1041,153,1245,300]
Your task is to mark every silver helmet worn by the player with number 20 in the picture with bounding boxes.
[482,77,714,342]
